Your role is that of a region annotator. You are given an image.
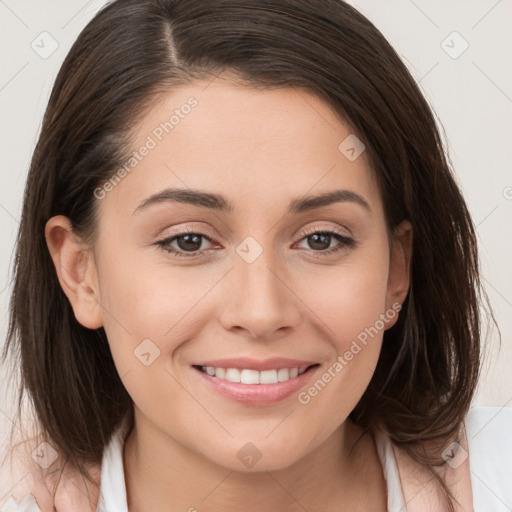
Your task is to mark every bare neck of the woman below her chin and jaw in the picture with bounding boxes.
[124,409,386,512]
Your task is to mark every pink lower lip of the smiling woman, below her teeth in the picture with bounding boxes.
[192,366,318,406]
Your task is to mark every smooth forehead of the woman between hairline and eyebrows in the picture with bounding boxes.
[100,78,379,218]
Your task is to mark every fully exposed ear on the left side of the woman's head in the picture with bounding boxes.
[45,215,103,329]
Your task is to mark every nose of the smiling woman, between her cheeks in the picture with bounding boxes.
[220,250,301,340]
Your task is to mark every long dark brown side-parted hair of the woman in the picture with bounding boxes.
[4,0,488,506]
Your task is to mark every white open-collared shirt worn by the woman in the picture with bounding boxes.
[97,407,512,512]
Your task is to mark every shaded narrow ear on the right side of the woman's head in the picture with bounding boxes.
[385,220,413,329]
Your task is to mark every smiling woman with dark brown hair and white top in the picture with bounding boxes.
[2,0,510,512]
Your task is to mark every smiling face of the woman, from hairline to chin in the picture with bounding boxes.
[50,78,410,470]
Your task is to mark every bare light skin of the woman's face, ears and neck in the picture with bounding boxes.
[46,76,412,512]
